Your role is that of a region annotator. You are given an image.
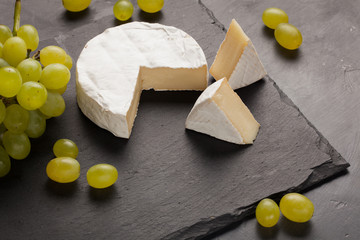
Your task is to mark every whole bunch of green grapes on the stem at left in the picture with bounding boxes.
[0,0,72,177]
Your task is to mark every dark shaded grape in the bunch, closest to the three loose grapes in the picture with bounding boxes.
[25,110,46,138]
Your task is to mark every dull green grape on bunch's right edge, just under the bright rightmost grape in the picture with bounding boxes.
[39,91,65,117]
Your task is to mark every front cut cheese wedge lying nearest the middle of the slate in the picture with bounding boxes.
[185,78,260,144]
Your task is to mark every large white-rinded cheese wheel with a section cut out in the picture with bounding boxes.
[76,22,208,138]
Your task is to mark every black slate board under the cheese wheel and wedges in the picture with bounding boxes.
[0,0,348,239]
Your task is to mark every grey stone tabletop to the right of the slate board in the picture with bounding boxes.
[200,0,360,240]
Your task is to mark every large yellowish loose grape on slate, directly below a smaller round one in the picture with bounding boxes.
[46,157,80,183]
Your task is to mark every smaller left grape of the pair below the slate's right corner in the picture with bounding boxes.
[255,198,280,227]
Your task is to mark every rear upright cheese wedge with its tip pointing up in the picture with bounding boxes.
[210,19,266,89]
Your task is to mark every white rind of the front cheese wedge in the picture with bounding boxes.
[185,79,244,144]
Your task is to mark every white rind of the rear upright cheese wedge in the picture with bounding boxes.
[228,41,267,89]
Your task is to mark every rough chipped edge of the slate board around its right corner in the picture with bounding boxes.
[162,76,350,240]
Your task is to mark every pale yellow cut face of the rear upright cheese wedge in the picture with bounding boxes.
[210,19,250,80]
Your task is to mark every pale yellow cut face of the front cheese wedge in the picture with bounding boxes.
[212,81,260,144]
